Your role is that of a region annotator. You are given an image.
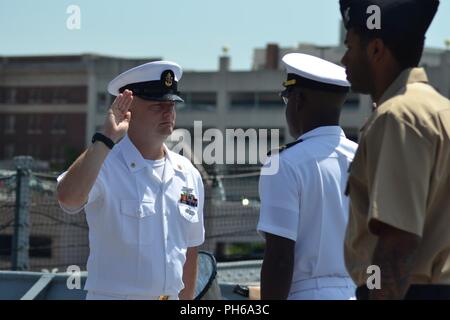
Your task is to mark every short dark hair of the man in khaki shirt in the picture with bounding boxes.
[354,28,425,70]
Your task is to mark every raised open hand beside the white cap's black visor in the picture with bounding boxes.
[103,90,133,143]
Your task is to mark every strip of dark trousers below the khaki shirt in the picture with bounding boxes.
[356,284,450,300]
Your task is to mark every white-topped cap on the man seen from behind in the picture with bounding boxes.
[282,53,350,92]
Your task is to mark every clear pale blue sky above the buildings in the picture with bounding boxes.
[0,0,450,71]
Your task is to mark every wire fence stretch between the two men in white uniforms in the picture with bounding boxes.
[204,171,263,261]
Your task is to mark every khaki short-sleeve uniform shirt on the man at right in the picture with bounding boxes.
[345,68,450,286]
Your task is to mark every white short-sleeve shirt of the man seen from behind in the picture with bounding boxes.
[257,126,357,291]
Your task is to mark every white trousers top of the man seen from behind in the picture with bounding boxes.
[288,277,356,300]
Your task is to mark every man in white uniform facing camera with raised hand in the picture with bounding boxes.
[57,61,204,300]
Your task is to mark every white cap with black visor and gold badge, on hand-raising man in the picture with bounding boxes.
[108,61,183,102]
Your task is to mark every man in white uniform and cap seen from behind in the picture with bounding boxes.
[257,53,357,300]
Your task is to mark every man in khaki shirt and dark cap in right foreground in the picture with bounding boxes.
[340,0,450,299]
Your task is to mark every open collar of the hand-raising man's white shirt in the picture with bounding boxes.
[117,135,184,182]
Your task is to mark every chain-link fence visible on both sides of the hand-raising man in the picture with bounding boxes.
[0,158,263,272]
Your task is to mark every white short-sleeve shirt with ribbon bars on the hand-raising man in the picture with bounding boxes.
[58,136,204,296]
